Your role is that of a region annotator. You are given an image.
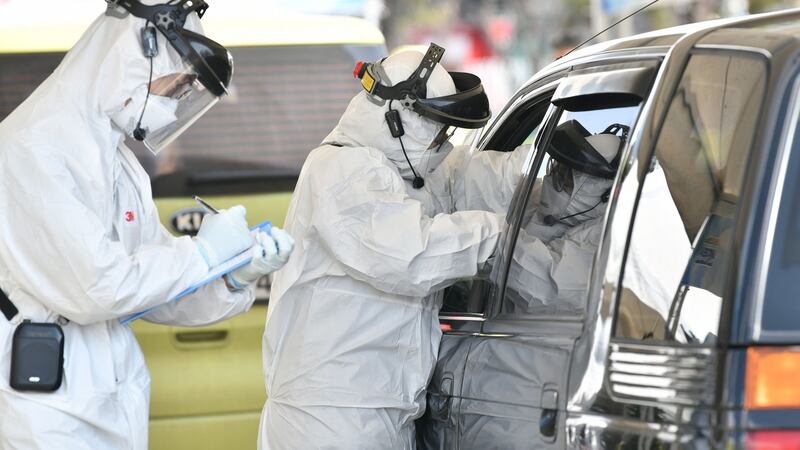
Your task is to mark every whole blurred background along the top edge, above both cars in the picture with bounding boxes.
[0,0,800,110]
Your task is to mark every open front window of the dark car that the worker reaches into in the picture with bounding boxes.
[441,91,552,314]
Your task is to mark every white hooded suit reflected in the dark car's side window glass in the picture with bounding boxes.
[506,134,620,313]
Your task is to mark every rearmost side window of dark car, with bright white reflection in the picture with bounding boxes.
[614,53,767,344]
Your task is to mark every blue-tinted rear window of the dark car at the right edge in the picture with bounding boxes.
[761,80,800,336]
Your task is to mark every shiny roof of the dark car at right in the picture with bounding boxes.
[526,8,800,85]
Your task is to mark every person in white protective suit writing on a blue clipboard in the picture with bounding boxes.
[0,0,292,450]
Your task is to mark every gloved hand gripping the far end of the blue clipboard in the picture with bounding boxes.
[228,227,294,289]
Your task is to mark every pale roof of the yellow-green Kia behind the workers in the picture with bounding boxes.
[0,10,385,54]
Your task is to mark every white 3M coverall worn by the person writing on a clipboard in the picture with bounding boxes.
[0,7,254,450]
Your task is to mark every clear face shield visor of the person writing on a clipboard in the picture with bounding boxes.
[141,66,219,154]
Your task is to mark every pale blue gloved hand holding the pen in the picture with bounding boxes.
[194,205,254,267]
